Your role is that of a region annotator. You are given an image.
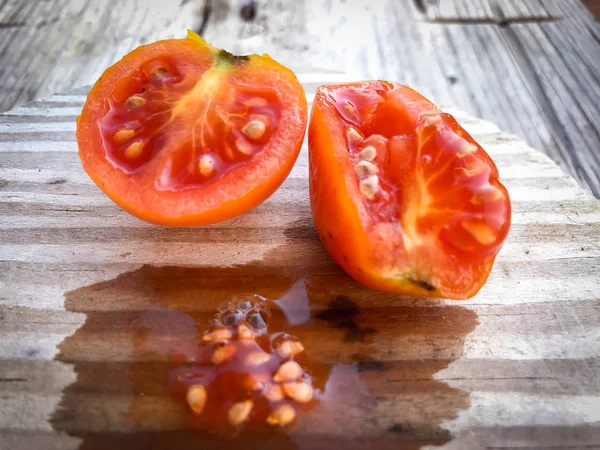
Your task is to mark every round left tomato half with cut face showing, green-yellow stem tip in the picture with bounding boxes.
[77,32,307,226]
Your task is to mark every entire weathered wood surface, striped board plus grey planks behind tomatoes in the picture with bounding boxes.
[0,0,600,450]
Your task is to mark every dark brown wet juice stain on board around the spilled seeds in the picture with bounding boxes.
[51,241,477,450]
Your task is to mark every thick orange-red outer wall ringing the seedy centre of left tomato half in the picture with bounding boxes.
[76,33,307,226]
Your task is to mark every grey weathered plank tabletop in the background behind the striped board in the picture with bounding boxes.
[0,0,600,197]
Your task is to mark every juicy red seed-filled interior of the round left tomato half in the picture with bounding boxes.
[98,58,281,191]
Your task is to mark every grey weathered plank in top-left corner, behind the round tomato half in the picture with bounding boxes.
[0,0,204,111]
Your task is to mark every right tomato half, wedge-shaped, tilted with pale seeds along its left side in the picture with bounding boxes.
[309,81,511,299]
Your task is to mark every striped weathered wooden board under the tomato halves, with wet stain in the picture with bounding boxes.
[0,79,600,450]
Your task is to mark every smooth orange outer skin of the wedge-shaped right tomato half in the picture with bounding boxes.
[308,82,510,300]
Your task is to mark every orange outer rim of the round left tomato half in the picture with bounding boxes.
[76,33,307,227]
